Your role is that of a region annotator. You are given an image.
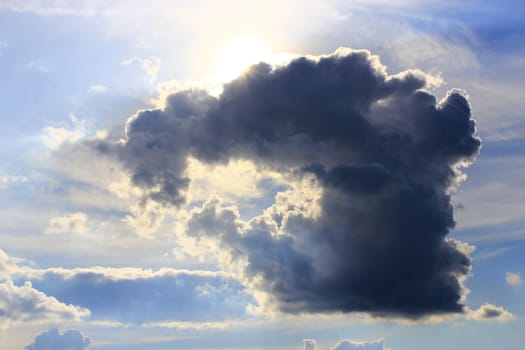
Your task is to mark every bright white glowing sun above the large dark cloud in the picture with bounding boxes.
[216,37,270,81]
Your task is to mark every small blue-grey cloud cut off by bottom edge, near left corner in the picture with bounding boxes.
[24,328,91,350]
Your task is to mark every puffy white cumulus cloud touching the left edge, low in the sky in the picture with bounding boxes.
[0,280,90,328]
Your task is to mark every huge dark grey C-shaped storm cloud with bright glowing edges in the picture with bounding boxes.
[106,49,480,318]
